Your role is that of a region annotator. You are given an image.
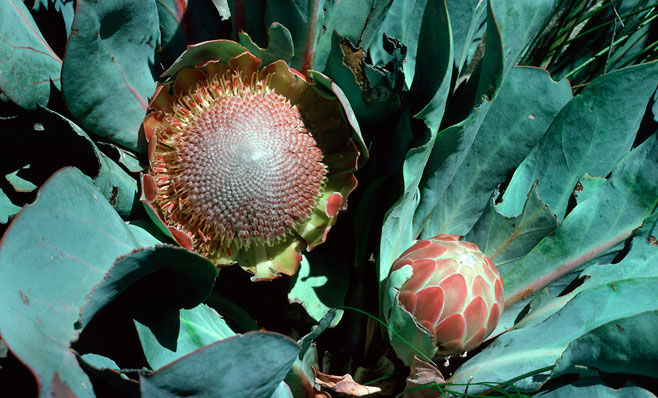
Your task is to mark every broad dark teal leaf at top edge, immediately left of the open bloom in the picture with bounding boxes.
[62,0,160,151]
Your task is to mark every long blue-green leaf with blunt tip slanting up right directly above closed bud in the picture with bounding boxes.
[423,67,571,237]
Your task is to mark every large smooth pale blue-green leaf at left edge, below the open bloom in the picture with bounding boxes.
[0,168,138,397]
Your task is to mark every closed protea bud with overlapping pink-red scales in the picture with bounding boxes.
[384,235,504,364]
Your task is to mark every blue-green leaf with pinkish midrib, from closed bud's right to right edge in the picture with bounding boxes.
[498,134,658,306]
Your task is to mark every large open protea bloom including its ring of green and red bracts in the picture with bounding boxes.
[142,40,364,280]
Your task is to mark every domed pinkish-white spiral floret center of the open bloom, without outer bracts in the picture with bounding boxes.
[152,75,326,252]
